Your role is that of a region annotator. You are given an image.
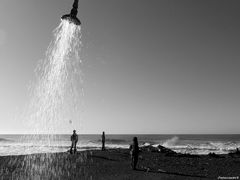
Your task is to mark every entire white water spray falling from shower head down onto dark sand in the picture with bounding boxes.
[15,20,83,177]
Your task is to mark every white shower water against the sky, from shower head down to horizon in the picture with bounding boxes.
[30,20,82,134]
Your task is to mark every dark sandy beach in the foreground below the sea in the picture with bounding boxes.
[0,146,240,180]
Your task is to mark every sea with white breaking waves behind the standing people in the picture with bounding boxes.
[0,134,240,156]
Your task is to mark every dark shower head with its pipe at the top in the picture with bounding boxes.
[61,0,81,26]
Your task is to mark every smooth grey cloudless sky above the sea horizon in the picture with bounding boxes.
[0,0,240,134]
